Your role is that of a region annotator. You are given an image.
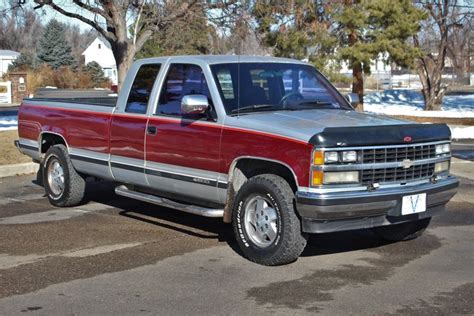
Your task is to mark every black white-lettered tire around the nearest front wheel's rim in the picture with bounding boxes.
[232,174,307,266]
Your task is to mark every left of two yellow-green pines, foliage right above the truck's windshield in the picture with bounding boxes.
[253,0,350,86]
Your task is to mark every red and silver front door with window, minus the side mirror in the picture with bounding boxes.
[146,63,226,202]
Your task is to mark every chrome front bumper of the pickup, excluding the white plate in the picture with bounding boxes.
[296,176,459,233]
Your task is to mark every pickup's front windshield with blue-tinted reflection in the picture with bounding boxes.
[211,63,352,114]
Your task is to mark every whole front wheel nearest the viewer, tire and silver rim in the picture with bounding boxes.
[232,174,307,266]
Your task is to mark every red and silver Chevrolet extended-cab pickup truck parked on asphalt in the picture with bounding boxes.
[17,56,458,265]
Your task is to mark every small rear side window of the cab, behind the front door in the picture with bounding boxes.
[125,64,161,114]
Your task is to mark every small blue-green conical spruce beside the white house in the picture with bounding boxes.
[38,19,76,69]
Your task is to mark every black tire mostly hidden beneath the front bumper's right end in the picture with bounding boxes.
[372,217,431,241]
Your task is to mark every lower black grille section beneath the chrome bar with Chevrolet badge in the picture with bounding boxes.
[361,163,435,184]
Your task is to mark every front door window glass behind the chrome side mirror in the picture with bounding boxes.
[156,64,212,116]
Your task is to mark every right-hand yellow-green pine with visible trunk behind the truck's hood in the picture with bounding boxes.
[335,0,426,110]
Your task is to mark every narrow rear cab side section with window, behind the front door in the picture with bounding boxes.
[110,64,161,186]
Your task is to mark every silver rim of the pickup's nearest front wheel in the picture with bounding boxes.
[244,195,278,248]
